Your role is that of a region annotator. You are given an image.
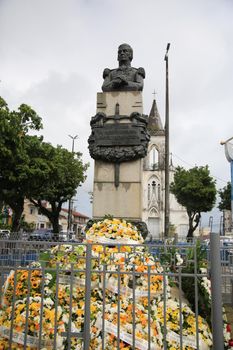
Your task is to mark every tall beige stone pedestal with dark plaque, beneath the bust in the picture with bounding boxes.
[90,91,145,221]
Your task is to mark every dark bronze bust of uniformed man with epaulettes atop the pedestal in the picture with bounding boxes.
[102,44,145,91]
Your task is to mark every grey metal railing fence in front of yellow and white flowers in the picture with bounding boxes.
[0,237,233,350]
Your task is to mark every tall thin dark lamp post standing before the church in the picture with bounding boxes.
[164,43,170,238]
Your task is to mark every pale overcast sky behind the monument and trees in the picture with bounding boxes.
[0,0,233,224]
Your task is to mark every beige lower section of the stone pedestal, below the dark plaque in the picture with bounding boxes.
[93,159,142,221]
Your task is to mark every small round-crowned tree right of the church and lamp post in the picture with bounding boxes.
[170,166,216,238]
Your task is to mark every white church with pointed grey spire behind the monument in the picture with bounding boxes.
[142,100,188,239]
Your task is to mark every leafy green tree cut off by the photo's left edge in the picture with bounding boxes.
[0,97,42,231]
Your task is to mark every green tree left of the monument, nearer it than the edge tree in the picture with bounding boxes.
[29,143,88,233]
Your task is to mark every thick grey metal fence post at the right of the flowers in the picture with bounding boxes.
[210,232,224,350]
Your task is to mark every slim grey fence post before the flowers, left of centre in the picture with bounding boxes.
[84,243,91,350]
